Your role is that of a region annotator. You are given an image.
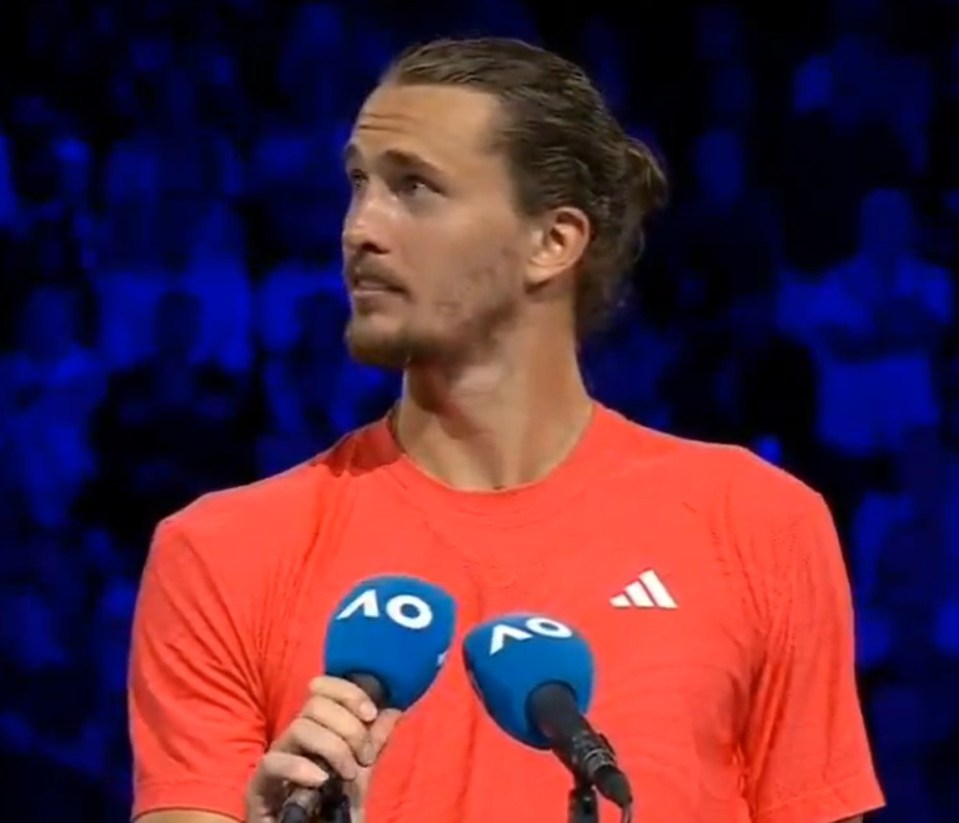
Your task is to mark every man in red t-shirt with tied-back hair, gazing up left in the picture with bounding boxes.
[131,39,882,823]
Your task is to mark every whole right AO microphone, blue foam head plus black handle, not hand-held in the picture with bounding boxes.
[463,614,632,810]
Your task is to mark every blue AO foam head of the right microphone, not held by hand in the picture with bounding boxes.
[463,614,594,749]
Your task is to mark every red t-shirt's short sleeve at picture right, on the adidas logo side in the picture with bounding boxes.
[743,493,884,823]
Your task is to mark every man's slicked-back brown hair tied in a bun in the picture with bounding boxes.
[383,37,668,337]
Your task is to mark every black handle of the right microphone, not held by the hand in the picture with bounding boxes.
[528,683,633,809]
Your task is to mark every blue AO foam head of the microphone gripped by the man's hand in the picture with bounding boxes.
[325,575,456,711]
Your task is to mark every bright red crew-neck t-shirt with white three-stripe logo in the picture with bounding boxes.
[130,407,883,823]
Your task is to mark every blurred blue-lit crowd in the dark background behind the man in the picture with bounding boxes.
[0,0,959,823]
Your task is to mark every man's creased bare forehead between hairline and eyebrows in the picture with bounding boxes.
[350,84,499,162]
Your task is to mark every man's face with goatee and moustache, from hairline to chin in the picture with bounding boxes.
[343,84,529,368]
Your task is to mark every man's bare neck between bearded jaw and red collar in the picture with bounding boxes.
[393,342,592,491]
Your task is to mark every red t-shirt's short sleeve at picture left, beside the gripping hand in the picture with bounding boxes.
[129,520,266,821]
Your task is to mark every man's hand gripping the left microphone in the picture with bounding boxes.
[246,677,400,823]
